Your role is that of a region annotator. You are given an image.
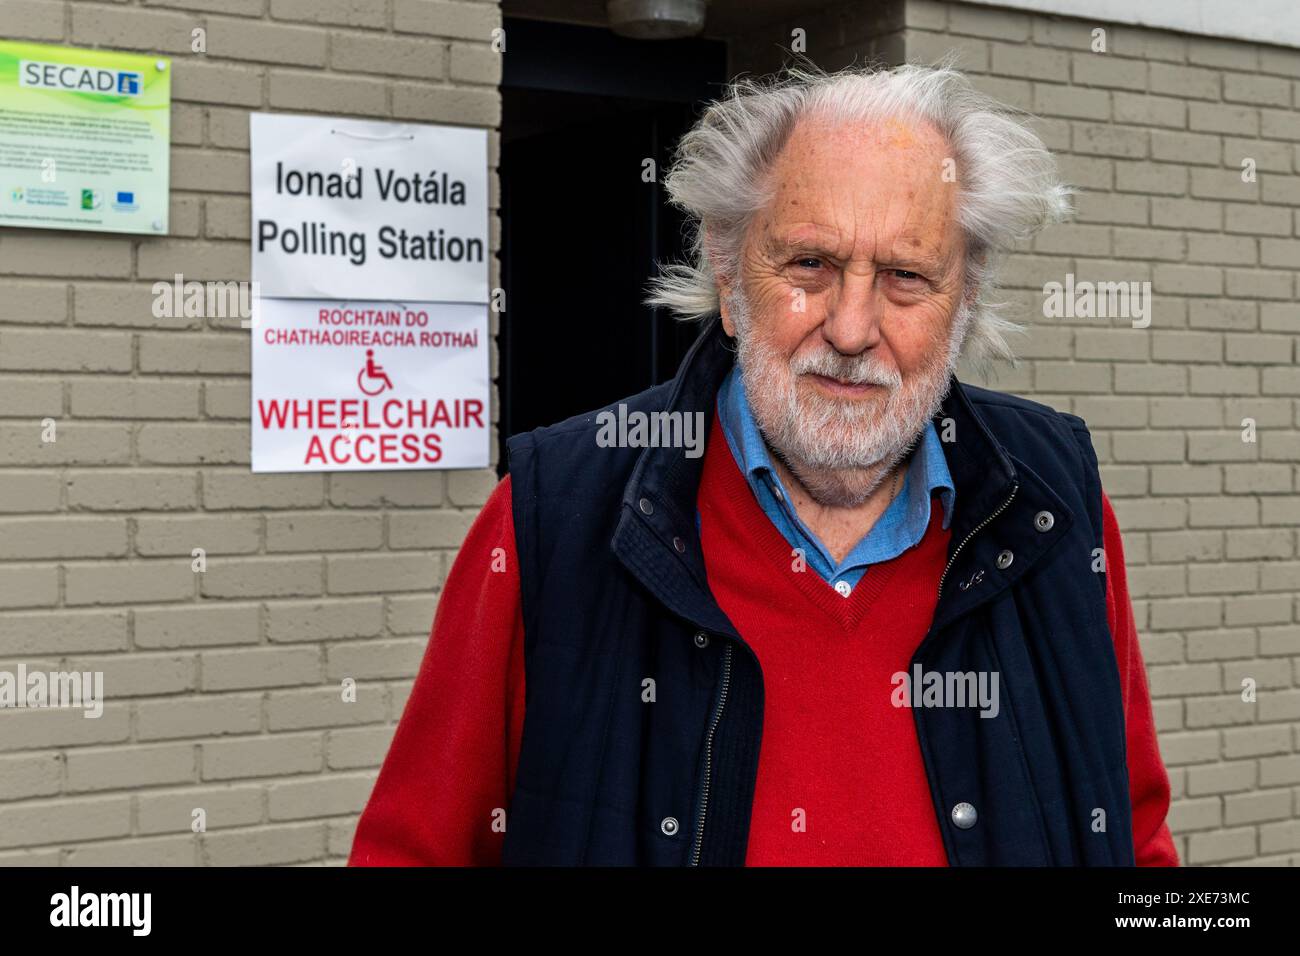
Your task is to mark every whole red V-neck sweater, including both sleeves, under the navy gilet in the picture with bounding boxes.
[348,418,1178,866]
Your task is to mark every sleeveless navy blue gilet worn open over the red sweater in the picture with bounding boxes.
[503,316,1134,866]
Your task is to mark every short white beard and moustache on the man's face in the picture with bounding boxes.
[731,289,971,507]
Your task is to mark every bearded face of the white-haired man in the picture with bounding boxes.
[720,120,970,505]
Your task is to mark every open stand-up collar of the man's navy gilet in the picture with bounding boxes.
[610,315,1081,639]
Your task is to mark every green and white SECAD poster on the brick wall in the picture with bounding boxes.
[0,40,172,235]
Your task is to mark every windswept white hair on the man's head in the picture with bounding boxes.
[646,57,1073,369]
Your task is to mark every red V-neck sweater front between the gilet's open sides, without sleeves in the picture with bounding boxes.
[699,421,949,866]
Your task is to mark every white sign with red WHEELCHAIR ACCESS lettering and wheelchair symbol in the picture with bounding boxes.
[252,298,490,472]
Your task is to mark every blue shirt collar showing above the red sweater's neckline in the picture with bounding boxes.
[718,365,957,597]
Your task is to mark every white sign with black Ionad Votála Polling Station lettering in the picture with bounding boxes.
[250,113,489,303]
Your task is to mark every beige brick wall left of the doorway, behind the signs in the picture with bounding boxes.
[0,0,501,866]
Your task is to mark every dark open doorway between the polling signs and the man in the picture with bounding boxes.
[498,18,725,475]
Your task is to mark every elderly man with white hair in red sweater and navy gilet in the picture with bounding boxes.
[350,59,1178,866]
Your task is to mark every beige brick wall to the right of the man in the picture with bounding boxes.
[732,0,1300,865]
